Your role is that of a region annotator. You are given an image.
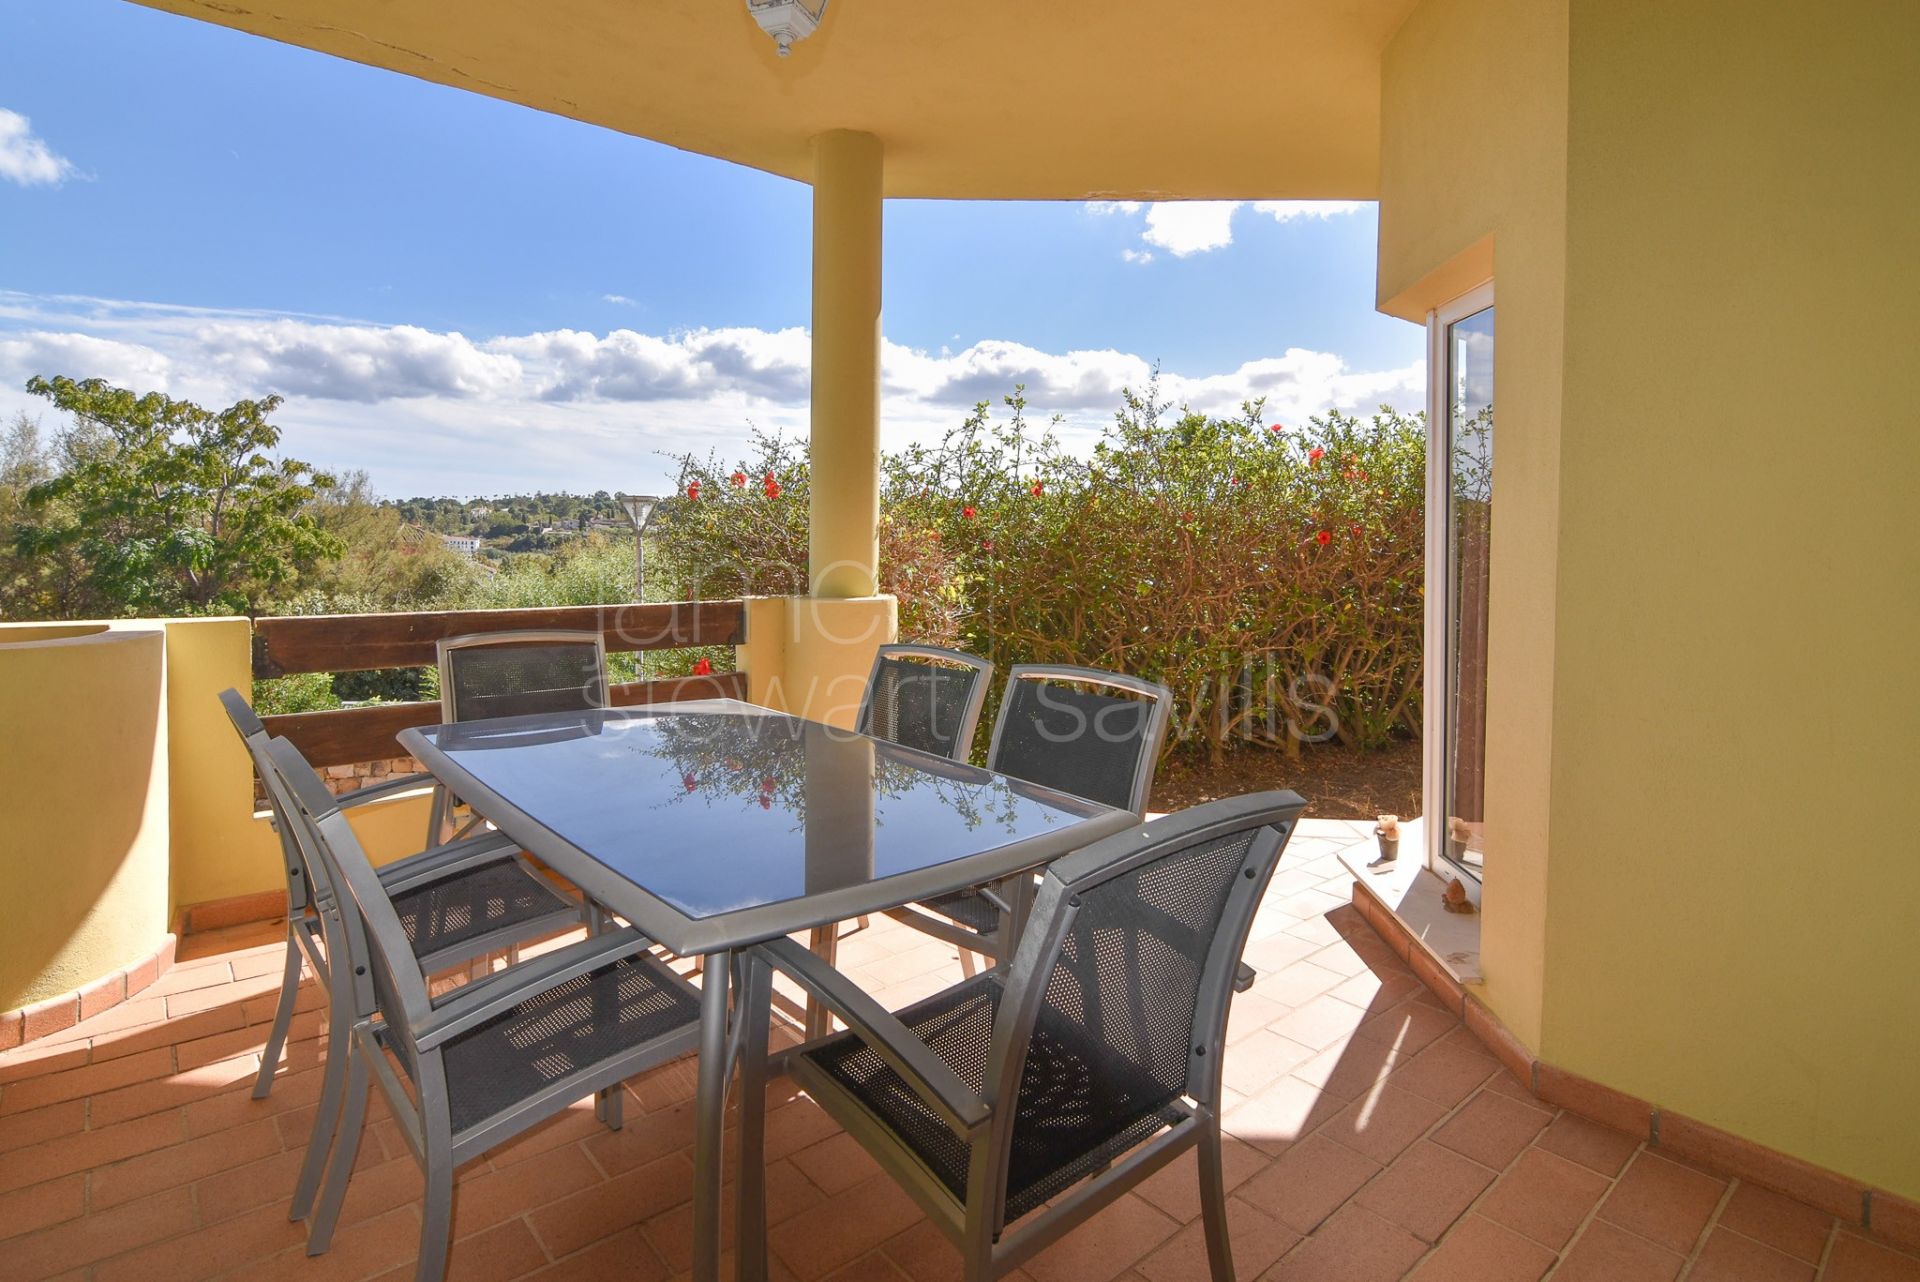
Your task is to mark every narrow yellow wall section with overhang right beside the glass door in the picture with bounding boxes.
[1379,0,1567,1044]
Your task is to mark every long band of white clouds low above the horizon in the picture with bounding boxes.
[0,292,1423,493]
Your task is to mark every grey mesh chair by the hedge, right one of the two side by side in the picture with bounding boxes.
[893,664,1173,973]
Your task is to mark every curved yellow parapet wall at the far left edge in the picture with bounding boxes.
[0,624,167,1009]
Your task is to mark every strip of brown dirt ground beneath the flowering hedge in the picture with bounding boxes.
[1150,739,1421,819]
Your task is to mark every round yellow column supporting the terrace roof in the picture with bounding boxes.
[808,129,881,597]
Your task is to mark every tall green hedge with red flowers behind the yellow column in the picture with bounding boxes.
[649,379,1425,758]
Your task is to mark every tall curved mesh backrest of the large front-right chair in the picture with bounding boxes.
[985,793,1306,1226]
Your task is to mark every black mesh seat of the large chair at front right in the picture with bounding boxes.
[806,971,1187,1221]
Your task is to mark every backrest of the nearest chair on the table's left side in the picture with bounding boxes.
[267,739,432,1073]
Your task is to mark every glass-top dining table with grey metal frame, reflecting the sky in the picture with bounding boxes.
[399,699,1135,1282]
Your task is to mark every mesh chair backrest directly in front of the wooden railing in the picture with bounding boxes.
[436,629,607,722]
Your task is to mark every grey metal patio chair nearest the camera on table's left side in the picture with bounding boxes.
[267,739,701,1282]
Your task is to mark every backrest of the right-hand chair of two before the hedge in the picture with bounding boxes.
[987,664,1173,816]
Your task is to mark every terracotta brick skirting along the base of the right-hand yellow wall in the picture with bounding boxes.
[1354,881,1920,1251]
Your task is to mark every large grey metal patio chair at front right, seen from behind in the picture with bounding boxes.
[739,793,1306,1282]
